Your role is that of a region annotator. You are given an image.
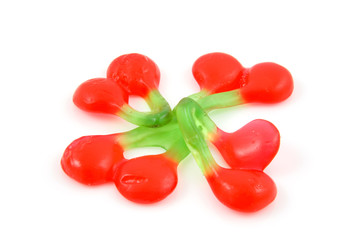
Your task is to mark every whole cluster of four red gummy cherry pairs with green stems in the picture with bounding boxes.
[61,52,293,212]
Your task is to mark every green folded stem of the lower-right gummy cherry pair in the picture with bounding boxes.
[176,98,217,176]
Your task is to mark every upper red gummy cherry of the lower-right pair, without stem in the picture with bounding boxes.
[213,119,280,171]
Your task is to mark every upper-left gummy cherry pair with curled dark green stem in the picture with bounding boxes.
[73,53,171,127]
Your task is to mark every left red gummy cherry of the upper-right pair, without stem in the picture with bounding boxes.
[192,52,244,93]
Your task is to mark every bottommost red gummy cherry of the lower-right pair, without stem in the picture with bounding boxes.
[207,168,277,212]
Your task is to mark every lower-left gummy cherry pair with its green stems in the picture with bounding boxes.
[61,120,188,203]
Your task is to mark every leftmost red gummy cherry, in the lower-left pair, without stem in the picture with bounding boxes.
[61,134,123,185]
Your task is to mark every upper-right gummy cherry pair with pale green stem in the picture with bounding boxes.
[192,52,294,109]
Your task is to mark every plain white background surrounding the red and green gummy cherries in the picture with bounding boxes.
[0,0,360,239]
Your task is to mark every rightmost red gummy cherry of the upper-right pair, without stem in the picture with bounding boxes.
[240,62,294,103]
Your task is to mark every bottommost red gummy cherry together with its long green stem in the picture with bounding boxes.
[176,98,277,212]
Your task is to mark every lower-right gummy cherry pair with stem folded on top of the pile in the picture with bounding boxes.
[177,98,279,212]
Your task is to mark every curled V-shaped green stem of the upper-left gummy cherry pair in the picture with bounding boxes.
[117,90,172,127]
